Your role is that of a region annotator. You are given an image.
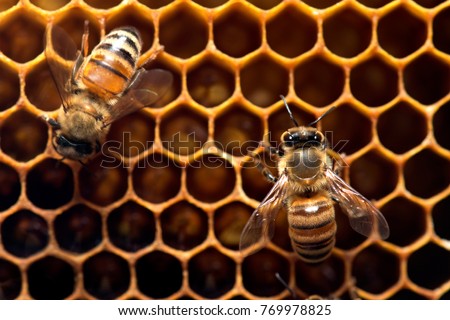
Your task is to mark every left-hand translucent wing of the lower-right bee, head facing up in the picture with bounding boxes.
[239,174,289,253]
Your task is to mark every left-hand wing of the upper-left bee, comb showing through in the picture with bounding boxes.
[44,24,81,110]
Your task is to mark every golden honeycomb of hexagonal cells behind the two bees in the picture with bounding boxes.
[0,0,450,299]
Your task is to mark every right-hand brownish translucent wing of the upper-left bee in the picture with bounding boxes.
[103,69,173,127]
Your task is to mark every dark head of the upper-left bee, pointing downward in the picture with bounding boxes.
[52,133,100,160]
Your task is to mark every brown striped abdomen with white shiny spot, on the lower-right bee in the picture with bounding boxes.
[288,194,336,263]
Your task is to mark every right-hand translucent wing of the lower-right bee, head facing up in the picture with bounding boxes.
[325,169,389,240]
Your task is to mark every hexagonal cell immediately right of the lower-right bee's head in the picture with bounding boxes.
[320,104,372,155]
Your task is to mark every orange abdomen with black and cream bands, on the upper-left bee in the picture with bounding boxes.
[81,27,142,96]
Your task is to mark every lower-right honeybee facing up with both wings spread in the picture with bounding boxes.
[240,96,389,263]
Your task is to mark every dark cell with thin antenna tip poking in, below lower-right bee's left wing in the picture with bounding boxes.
[242,249,289,297]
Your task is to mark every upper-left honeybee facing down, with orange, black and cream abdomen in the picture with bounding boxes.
[44,21,172,162]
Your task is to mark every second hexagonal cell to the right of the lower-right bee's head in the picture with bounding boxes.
[377,102,428,154]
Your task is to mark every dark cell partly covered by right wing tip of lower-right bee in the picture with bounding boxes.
[381,197,426,246]
